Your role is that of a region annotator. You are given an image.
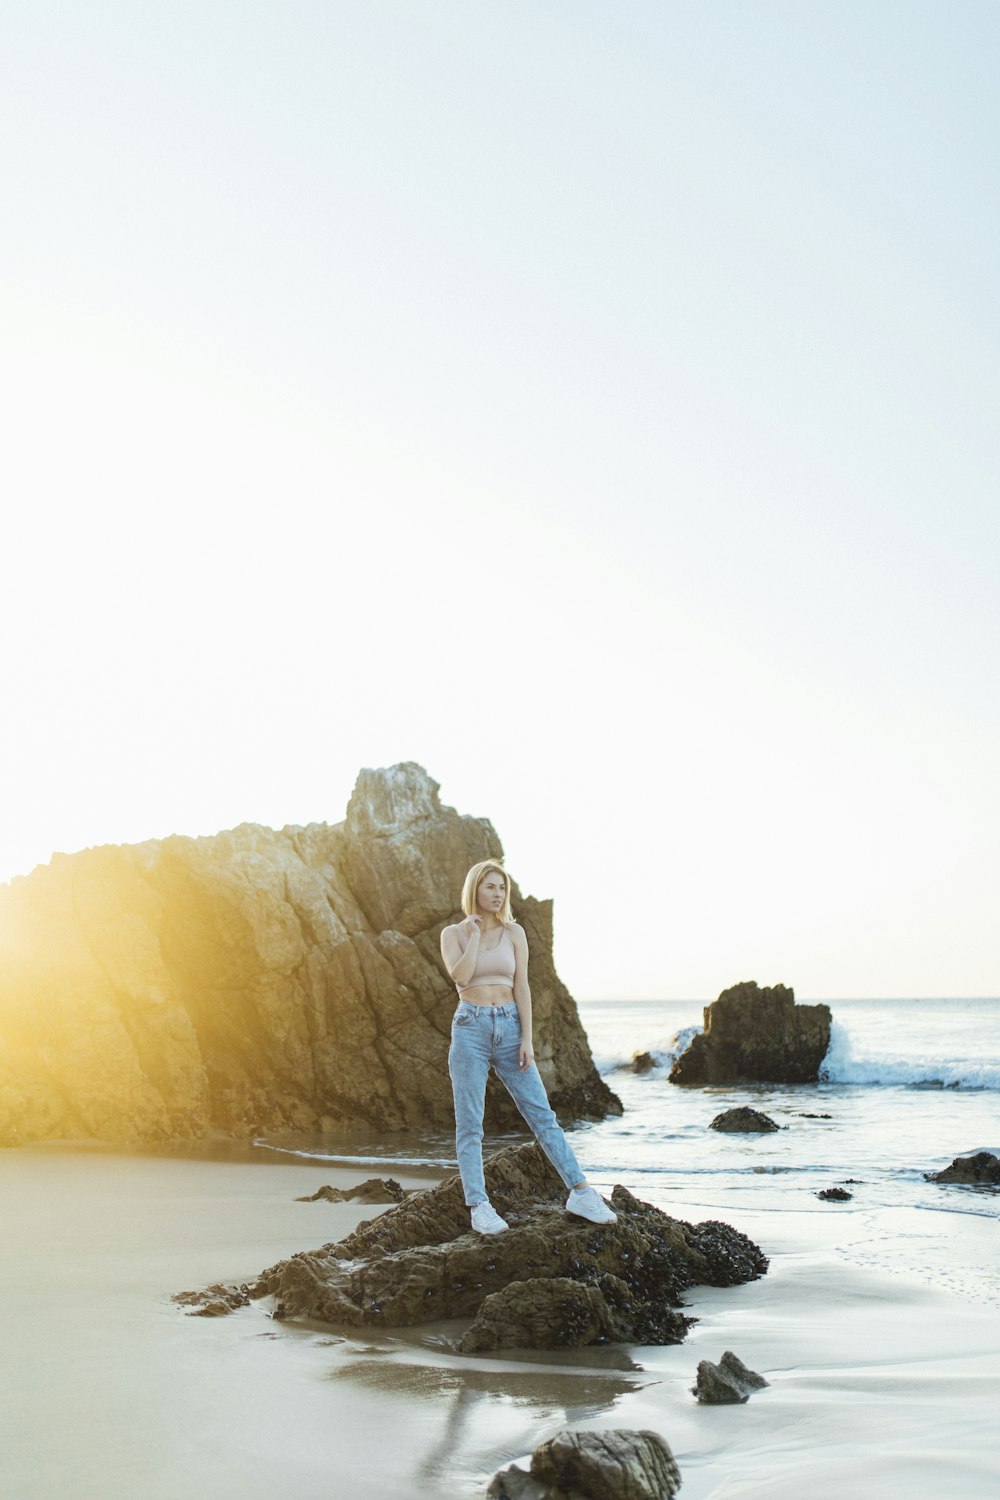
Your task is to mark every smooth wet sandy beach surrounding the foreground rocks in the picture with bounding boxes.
[0,1148,1000,1500]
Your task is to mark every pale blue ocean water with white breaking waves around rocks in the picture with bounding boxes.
[258,999,1000,1305]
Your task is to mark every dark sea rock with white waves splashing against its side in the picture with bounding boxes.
[670,980,831,1086]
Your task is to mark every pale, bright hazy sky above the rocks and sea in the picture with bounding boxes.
[0,0,1000,999]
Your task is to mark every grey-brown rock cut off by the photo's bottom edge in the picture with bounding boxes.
[486,1428,681,1500]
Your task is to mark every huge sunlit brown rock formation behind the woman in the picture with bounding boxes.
[0,764,621,1145]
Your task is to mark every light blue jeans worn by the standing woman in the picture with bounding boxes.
[448,1001,583,1208]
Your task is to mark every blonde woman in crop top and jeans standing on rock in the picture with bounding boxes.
[441,860,618,1235]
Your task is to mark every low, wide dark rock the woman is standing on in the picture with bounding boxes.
[189,1143,768,1352]
